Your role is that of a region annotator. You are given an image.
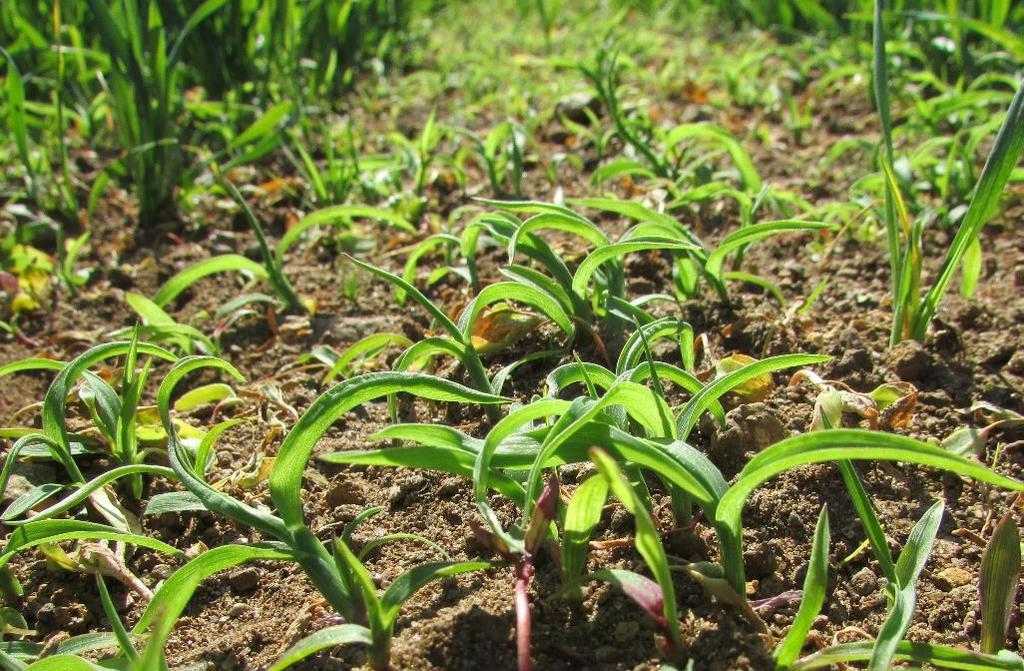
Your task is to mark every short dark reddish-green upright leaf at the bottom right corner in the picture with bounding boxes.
[978,513,1021,655]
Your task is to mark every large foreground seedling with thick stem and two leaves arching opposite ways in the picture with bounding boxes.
[157,357,507,667]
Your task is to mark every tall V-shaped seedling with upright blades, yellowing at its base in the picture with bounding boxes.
[872,0,1024,345]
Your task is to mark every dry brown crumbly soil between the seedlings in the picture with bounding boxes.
[0,26,1024,671]
